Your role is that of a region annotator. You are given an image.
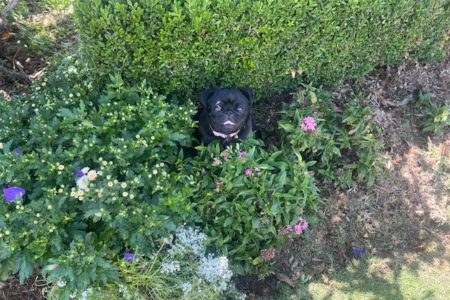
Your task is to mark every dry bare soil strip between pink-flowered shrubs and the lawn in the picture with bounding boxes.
[270,59,450,292]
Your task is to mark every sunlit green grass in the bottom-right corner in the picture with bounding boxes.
[268,241,450,300]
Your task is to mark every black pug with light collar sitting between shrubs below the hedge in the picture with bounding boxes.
[198,88,255,148]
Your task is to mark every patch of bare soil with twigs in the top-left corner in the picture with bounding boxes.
[0,1,77,100]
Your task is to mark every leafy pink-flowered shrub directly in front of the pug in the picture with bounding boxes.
[187,139,318,274]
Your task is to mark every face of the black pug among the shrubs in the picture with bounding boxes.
[200,88,253,134]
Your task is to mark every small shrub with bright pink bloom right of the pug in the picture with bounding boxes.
[279,87,382,188]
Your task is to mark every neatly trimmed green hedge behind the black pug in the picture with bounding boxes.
[75,0,450,96]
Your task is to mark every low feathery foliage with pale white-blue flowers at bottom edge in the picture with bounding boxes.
[46,226,245,300]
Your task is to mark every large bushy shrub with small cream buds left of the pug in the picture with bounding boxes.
[0,57,197,296]
